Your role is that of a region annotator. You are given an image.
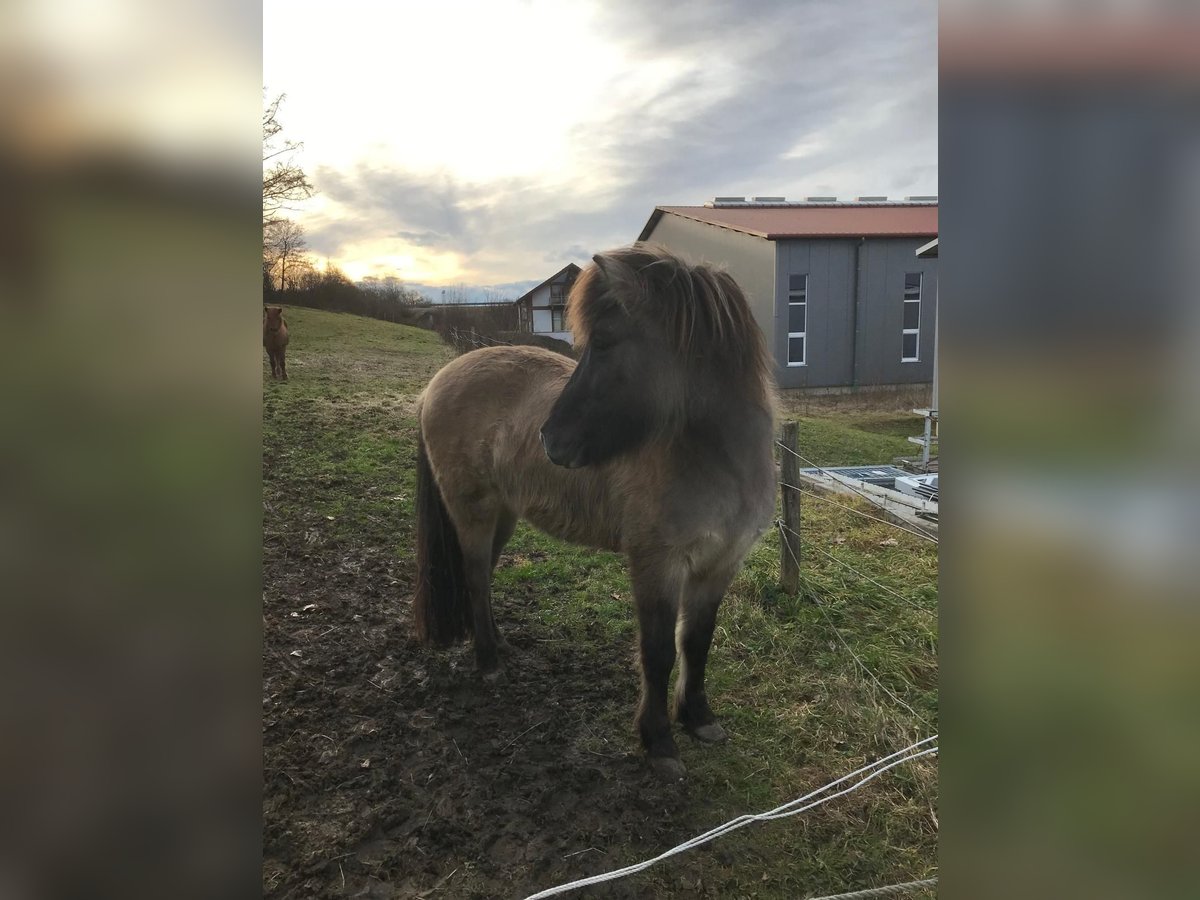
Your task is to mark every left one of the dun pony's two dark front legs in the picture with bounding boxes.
[630,565,686,781]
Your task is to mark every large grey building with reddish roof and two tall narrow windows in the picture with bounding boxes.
[638,197,937,388]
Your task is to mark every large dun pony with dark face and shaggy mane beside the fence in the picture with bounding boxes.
[414,245,776,779]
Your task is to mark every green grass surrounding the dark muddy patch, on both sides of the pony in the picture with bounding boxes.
[263,308,938,898]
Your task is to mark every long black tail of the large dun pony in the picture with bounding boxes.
[413,433,473,646]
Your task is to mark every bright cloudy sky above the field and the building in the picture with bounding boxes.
[263,0,937,284]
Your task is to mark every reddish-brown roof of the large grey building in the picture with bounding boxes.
[638,203,937,241]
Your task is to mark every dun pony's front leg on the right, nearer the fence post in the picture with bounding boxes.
[674,572,733,743]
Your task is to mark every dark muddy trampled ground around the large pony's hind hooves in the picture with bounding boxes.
[263,511,710,898]
